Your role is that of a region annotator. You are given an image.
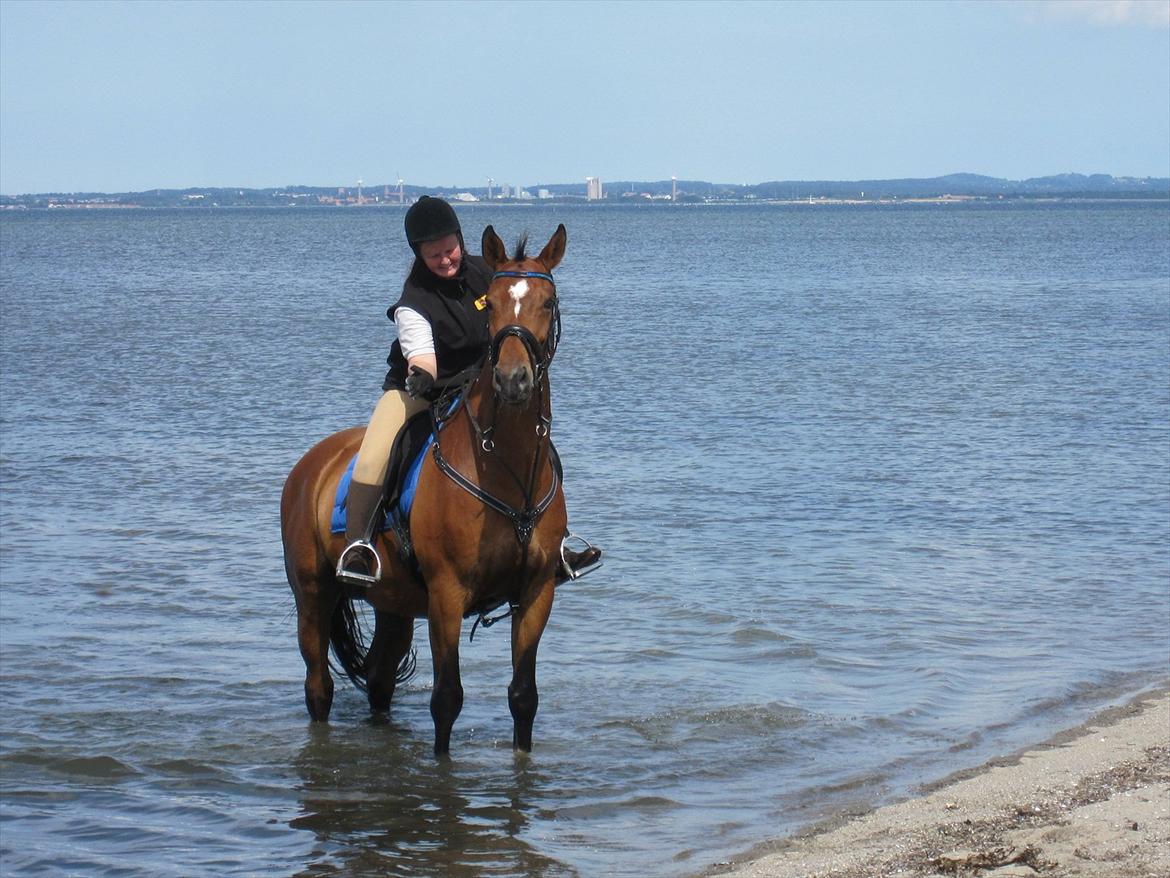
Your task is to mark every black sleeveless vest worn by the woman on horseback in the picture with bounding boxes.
[381,254,491,390]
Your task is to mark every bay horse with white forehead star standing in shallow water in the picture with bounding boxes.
[281,225,567,755]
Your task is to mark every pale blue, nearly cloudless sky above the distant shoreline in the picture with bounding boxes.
[0,0,1170,194]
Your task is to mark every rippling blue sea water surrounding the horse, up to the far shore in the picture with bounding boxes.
[0,204,1170,876]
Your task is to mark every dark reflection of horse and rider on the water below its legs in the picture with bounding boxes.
[289,721,577,878]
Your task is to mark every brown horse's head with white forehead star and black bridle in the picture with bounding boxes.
[483,225,566,405]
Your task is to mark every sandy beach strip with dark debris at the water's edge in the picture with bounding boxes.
[716,687,1170,878]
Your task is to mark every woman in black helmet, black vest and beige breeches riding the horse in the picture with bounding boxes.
[337,196,601,588]
